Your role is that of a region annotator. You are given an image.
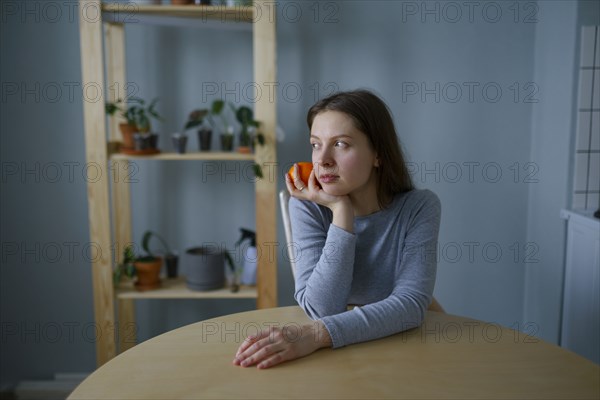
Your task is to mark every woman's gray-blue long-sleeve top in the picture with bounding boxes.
[289,189,441,348]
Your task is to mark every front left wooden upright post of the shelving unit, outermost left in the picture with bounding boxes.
[78,0,116,366]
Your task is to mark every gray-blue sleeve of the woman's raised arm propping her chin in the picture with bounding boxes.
[288,197,356,319]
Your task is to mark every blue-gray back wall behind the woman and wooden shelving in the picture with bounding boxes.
[0,1,593,385]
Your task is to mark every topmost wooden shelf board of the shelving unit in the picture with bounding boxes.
[102,3,255,23]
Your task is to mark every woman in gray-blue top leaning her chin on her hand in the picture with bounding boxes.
[233,90,441,368]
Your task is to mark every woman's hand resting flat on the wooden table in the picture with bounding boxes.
[233,321,331,369]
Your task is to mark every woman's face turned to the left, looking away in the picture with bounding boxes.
[310,111,379,196]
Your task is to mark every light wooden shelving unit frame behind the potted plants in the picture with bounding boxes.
[79,0,277,366]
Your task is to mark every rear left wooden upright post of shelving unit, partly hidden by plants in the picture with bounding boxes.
[104,19,136,353]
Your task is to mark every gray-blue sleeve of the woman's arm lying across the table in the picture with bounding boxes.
[322,191,441,348]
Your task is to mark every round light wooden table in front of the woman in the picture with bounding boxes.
[69,306,600,400]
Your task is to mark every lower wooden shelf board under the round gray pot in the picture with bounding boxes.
[115,277,258,300]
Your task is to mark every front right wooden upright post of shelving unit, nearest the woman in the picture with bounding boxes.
[252,0,280,308]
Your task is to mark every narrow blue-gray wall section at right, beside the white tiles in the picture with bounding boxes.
[524,1,600,343]
